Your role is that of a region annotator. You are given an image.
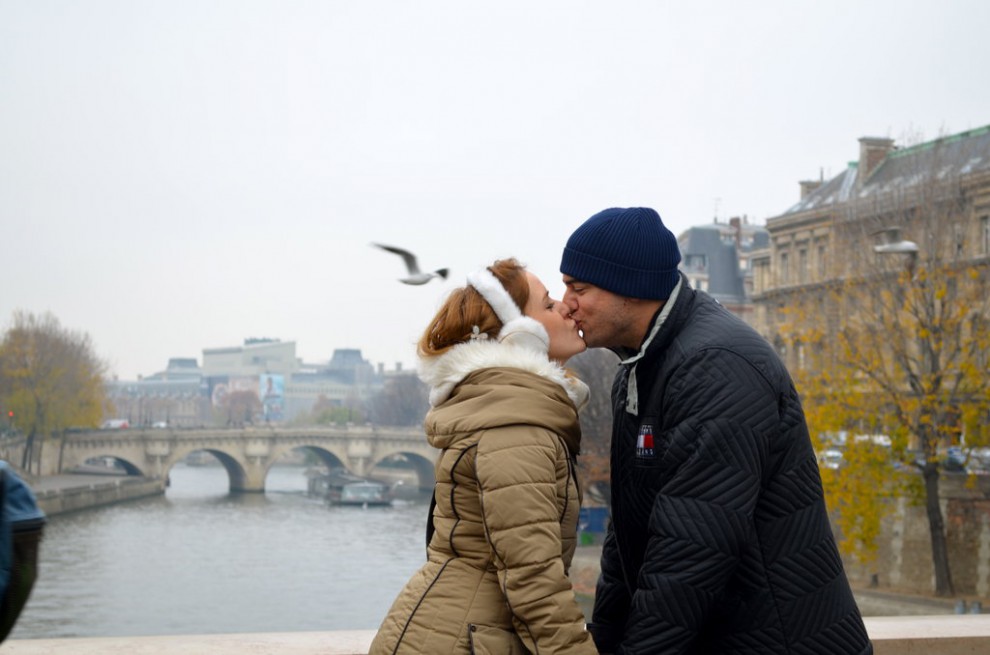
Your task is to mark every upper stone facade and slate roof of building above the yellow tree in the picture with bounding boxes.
[751,126,990,358]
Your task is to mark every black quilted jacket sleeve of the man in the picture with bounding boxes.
[617,349,779,654]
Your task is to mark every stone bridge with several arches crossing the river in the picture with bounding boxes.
[21,426,438,492]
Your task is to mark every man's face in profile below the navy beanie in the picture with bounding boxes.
[563,275,642,348]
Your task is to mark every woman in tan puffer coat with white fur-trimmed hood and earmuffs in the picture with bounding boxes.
[371,259,597,655]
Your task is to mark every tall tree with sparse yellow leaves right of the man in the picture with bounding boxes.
[778,135,990,596]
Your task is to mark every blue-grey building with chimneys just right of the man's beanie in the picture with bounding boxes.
[677,217,769,320]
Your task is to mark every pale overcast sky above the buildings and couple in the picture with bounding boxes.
[0,0,990,379]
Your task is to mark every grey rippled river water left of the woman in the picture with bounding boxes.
[9,465,429,639]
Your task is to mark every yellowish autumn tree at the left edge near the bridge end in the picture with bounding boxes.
[0,312,106,471]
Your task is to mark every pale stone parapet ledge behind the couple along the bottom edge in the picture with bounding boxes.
[0,614,990,655]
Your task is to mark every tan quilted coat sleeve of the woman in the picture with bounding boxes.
[476,426,597,653]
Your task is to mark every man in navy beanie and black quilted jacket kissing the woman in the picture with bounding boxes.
[560,208,873,655]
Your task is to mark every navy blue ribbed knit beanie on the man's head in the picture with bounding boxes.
[560,207,681,300]
